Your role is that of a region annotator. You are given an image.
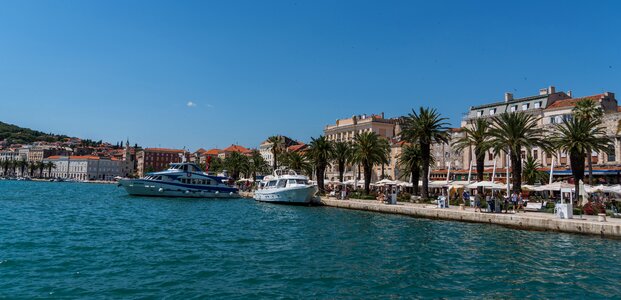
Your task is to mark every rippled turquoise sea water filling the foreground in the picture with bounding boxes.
[0,181,621,299]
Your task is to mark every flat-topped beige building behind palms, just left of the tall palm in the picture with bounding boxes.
[323,113,399,182]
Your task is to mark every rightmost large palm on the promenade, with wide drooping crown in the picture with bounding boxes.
[552,118,611,199]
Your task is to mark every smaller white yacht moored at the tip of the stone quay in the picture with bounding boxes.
[254,170,317,204]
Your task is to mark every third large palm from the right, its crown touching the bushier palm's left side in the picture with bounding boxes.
[454,118,490,186]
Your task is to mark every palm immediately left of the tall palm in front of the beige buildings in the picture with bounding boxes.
[352,131,390,195]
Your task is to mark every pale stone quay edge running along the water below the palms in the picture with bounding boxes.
[321,199,621,238]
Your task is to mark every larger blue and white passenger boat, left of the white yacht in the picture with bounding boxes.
[118,162,239,198]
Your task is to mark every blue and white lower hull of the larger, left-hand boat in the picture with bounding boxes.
[119,179,239,198]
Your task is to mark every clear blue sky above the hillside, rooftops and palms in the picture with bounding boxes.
[0,0,621,150]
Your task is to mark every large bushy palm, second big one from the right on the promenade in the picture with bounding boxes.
[489,112,550,193]
